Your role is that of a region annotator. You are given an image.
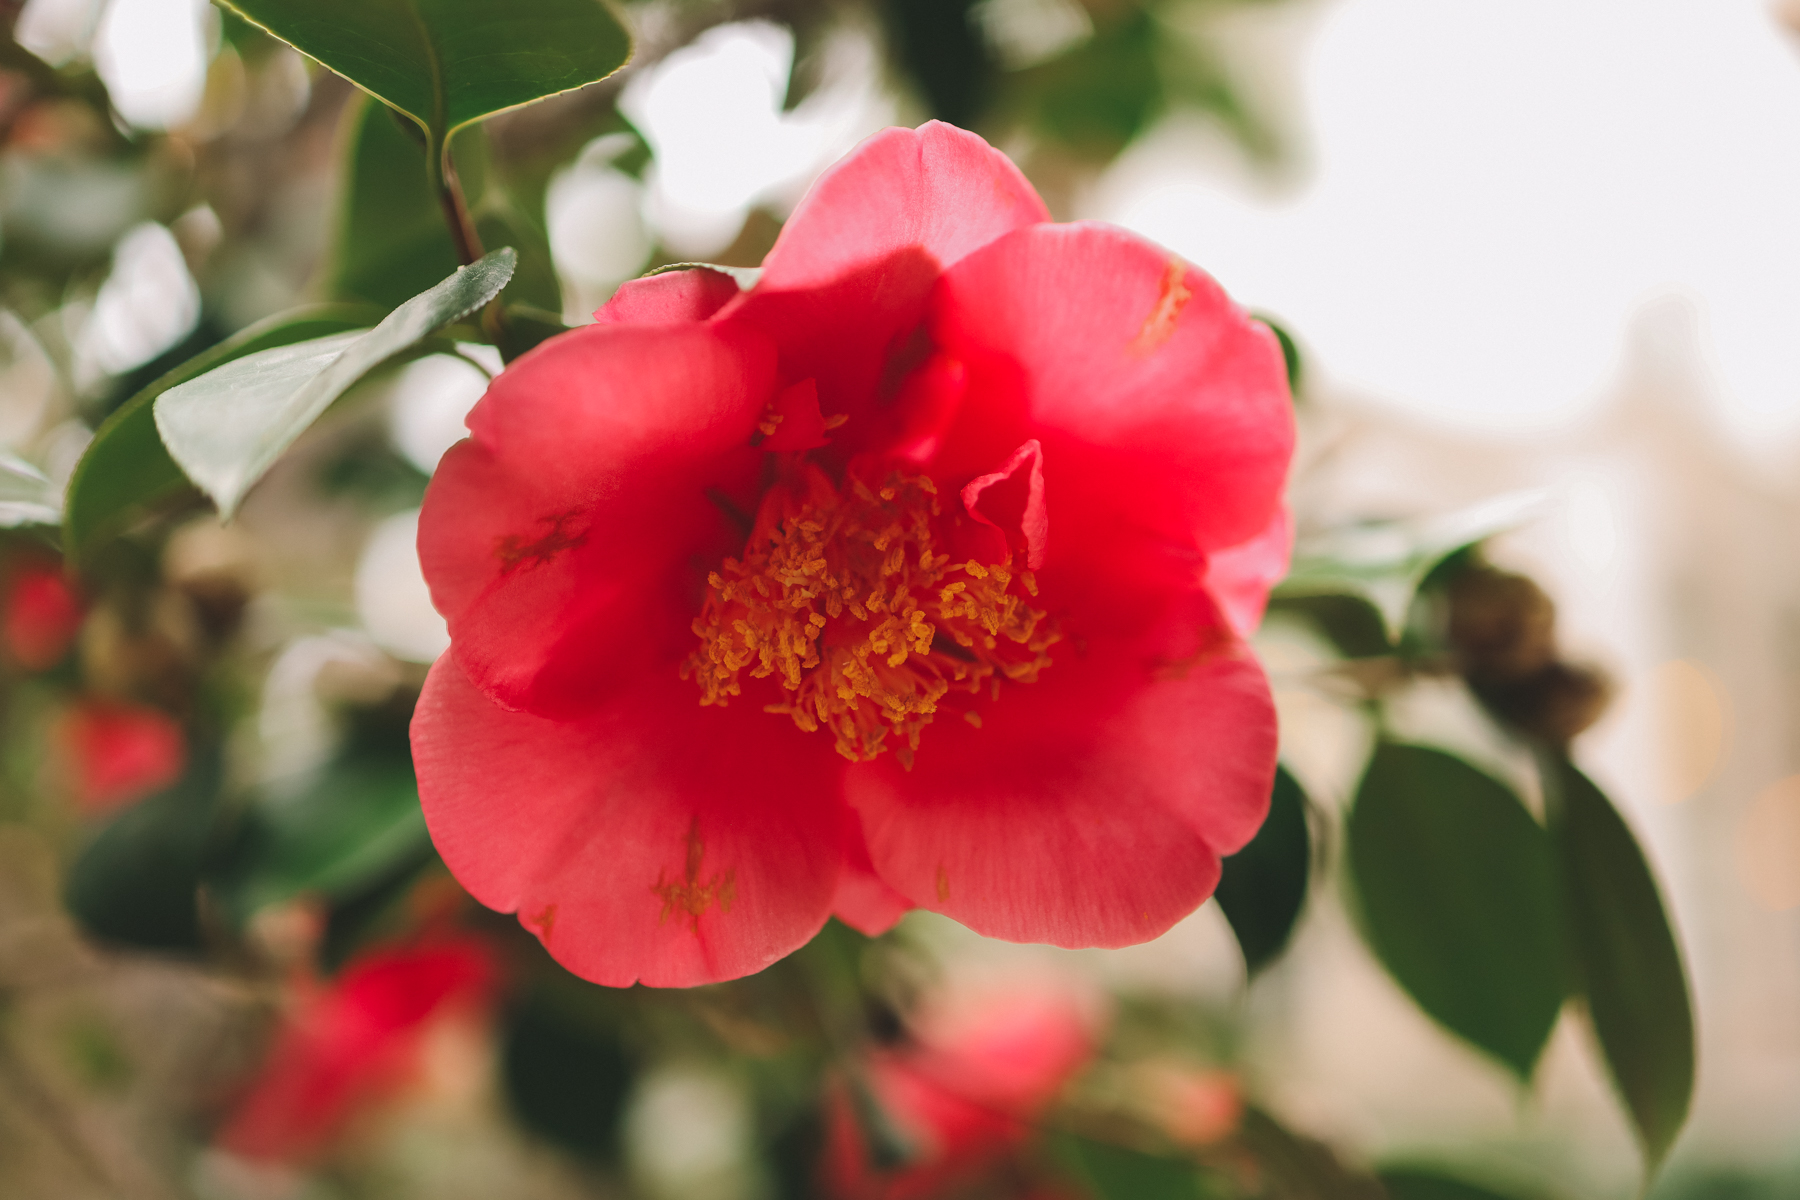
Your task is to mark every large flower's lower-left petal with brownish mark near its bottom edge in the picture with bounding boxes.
[412,655,846,988]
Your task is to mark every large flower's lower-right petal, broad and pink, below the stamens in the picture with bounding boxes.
[846,576,1276,946]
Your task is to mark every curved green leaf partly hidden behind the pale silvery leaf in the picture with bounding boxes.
[63,304,380,561]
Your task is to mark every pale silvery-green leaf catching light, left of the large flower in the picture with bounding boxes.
[155,248,517,518]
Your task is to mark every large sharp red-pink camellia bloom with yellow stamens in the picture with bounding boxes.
[412,122,1292,984]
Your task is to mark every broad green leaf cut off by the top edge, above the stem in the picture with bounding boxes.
[221,0,632,144]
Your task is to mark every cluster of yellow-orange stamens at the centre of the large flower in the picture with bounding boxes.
[682,464,1060,766]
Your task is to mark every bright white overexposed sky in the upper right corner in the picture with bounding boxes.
[1096,0,1800,437]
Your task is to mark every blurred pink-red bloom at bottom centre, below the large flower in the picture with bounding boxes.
[824,988,1094,1200]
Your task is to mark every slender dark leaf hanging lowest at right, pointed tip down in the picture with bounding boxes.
[1539,752,1694,1173]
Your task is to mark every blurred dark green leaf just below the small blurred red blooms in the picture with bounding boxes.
[63,747,221,950]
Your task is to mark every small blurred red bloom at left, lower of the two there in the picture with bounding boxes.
[56,698,187,815]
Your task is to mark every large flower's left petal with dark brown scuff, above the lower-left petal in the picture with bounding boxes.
[419,326,772,712]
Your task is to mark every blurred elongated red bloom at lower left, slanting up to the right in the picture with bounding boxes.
[218,937,497,1162]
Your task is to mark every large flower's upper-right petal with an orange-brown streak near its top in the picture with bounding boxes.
[932,225,1294,568]
